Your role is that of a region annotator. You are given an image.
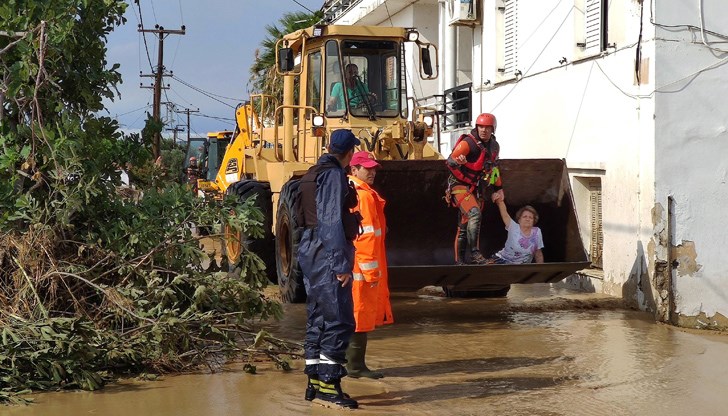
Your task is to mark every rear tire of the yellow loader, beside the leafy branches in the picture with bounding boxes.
[223,180,278,284]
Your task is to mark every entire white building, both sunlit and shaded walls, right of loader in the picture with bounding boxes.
[328,0,728,326]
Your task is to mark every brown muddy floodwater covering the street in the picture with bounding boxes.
[8,285,728,416]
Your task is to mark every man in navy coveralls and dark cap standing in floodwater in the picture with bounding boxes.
[298,129,361,408]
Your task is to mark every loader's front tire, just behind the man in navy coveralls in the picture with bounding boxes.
[275,180,306,303]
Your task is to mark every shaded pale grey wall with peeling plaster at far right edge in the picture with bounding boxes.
[654,0,728,326]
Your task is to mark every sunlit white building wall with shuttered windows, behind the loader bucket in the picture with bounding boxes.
[474,0,655,307]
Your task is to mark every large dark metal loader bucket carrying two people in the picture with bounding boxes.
[375,159,590,290]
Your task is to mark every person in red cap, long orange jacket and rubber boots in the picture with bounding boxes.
[346,151,394,378]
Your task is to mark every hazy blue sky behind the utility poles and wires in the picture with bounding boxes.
[106,0,324,137]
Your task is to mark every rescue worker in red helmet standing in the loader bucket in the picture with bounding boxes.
[446,113,504,264]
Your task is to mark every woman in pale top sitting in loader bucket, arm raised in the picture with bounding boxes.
[486,195,543,264]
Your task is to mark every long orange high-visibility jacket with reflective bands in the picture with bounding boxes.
[349,176,394,332]
